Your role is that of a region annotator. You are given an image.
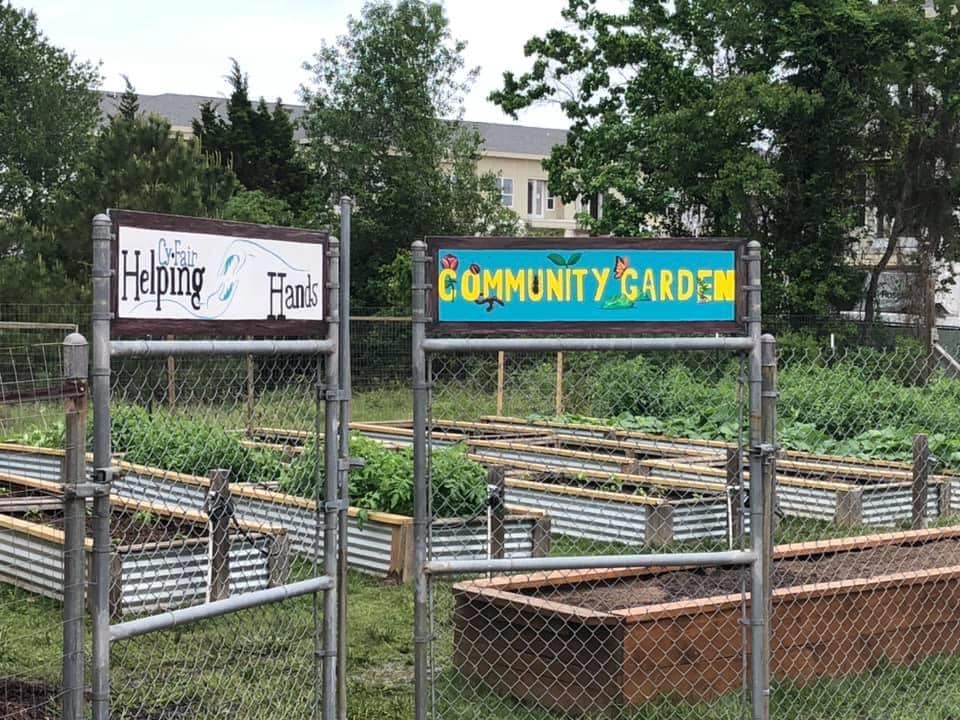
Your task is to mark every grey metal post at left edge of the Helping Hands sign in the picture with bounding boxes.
[90,214,112,720]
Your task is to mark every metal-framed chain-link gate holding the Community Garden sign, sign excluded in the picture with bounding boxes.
[412,242,776,720]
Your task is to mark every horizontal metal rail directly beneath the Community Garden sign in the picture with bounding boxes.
[423,336,755,353]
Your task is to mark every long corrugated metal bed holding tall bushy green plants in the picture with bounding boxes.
[0,445,550,582]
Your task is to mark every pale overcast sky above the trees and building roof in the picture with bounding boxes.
[20,0,568,128]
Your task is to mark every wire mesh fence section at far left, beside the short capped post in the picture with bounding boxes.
[0,344,75,718]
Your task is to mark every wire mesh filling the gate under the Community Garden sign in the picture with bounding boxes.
[420,352,750,720]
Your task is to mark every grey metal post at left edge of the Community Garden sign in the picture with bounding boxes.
[412,240,430,720]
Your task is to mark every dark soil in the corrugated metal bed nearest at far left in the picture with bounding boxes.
[0,483,207,544]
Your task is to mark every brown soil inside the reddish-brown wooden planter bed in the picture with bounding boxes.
[522,539,960,612]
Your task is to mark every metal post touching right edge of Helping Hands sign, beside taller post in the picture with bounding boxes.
[317,233,340,720]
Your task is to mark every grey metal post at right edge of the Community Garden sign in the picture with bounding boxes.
[746,241,770,720]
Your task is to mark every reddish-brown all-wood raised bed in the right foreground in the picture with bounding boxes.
[453,528,960,713]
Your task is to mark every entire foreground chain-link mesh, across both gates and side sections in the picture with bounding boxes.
[9,312,960,720]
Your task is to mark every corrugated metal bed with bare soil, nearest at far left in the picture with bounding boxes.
[0,470,289,616]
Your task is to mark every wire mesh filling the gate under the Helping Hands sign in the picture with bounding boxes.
[101,355,323,718]
